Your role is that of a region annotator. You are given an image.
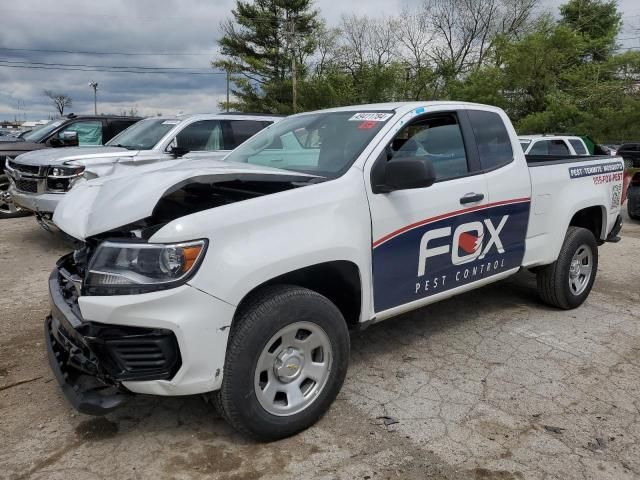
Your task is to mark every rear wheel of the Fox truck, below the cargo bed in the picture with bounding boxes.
[537,227,598,310]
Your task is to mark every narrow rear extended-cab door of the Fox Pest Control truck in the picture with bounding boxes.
[465,109,532,278]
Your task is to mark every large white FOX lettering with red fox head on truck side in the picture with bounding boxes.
[418,215,509,277]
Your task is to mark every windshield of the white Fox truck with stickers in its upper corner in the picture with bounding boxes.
[225,111,394,178]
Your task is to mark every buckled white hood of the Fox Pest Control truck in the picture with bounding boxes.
[53,159,313,240]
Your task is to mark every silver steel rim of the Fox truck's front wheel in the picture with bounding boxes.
[254,322,333,417]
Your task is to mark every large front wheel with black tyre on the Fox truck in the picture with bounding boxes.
[214,285,349,441]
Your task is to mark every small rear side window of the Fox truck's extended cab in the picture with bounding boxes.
[468,110,513,170]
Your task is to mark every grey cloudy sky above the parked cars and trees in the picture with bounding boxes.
[0,0,640,120]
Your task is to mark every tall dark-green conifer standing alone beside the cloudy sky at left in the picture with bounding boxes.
[212,0,321,113]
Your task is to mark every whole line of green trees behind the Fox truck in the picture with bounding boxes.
[214,0,640,141]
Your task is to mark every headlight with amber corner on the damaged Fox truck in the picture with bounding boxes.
[84,240,207,295]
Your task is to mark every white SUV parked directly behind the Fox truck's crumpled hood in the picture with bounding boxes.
[6,114,277,228]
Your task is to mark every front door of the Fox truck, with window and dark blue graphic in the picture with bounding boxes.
[365,111,490,317]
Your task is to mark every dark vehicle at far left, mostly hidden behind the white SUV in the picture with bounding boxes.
[0,114,140,219]
